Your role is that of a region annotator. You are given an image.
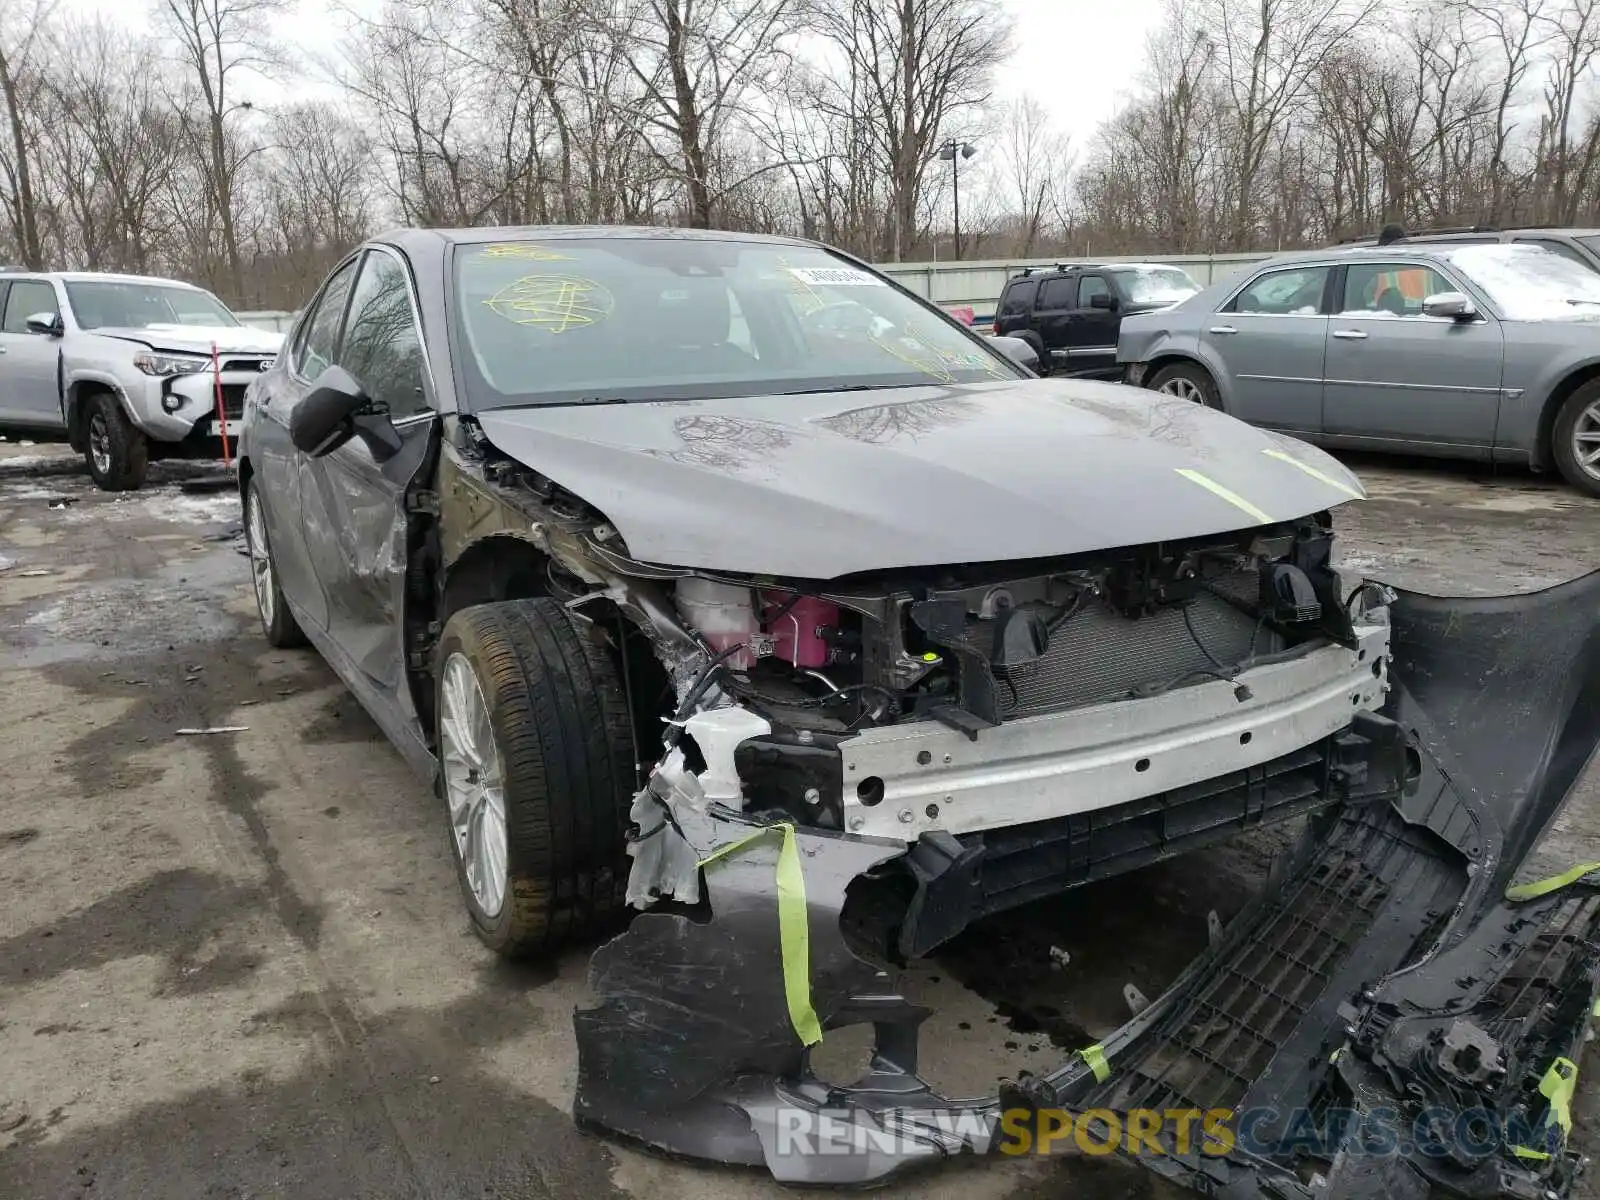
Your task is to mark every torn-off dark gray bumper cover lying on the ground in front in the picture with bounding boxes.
[574,573,1600,1200]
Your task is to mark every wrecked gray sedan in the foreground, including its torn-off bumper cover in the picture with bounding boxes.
[240,229,1600,1197]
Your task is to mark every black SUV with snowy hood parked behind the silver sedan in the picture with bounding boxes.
[995,262,1200,379]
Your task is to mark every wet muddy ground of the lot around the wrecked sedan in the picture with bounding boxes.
[0,445,1600,1200]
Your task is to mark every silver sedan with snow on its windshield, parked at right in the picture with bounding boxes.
[1117,245,1600,496]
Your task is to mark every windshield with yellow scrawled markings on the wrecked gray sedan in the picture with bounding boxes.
[456,238,1018,408]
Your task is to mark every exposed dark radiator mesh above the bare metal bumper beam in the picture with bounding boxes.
[966,578,1283,720]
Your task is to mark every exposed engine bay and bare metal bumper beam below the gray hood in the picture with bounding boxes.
[438,432,1403,954]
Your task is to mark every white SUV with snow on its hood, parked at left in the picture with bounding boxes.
[0,270,283,491]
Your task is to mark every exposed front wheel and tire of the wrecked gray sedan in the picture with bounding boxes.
[434,597,634,958]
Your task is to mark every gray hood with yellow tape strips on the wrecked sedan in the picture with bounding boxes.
[477,379,1365,579]
